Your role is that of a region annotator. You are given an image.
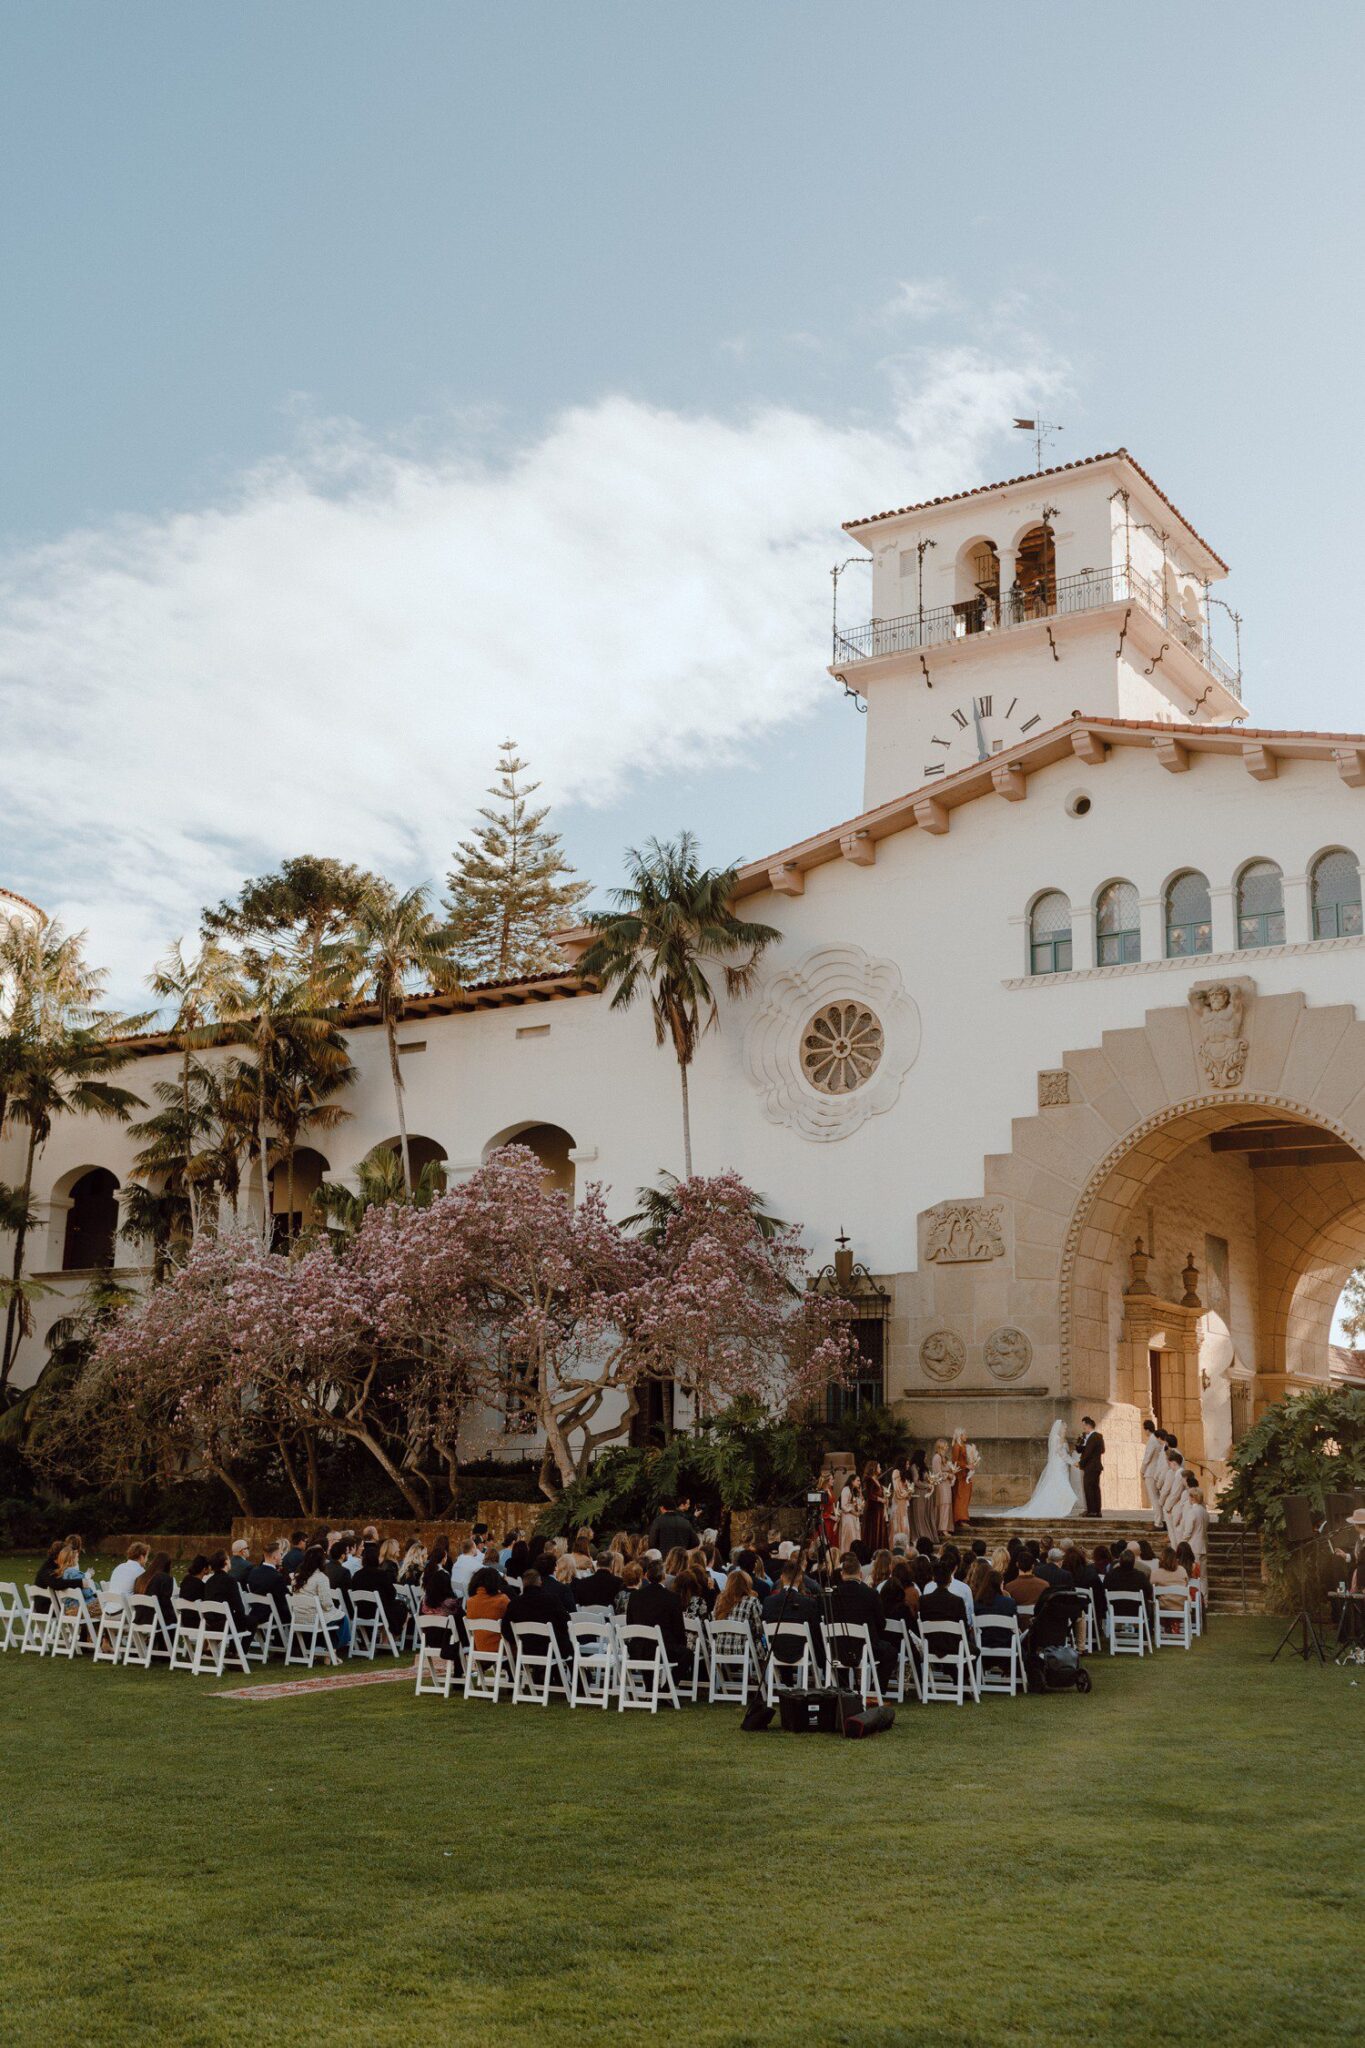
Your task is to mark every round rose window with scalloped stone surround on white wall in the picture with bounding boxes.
[743,946,919,1143]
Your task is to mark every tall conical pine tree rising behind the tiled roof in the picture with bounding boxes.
[446,739,591,981]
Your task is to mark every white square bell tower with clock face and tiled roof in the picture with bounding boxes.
[829,449,1246,809]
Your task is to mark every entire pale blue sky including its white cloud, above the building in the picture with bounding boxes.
[0,0,1365,997]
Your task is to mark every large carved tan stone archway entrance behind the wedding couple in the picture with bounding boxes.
[902,977,1365,1507]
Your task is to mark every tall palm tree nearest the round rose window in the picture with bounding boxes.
[579,831,782,1180]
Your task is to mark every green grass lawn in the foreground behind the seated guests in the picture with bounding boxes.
[0,1597,1365,2048]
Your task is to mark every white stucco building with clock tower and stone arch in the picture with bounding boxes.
[0,451,1365,1505]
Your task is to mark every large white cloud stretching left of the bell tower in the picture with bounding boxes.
[0,348,1056,997]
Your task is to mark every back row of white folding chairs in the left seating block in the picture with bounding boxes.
[0,1581,415,1677]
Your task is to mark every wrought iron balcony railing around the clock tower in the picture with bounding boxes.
[835,569,1242,698]
